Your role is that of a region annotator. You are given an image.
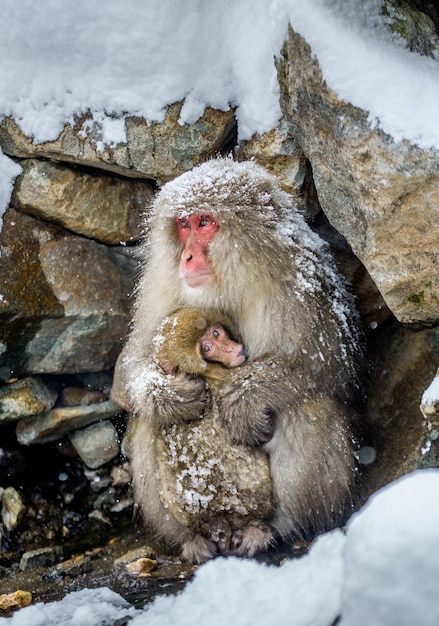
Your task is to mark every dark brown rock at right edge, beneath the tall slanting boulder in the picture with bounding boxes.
[366,323,439,493]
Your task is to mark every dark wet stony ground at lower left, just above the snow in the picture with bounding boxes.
[0,528,306,617]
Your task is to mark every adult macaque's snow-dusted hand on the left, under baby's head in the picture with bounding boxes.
[129,361,207,426]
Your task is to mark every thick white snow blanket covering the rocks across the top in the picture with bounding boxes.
[0,0,439,224]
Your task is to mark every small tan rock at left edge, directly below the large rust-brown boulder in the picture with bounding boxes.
[0,377,57,423]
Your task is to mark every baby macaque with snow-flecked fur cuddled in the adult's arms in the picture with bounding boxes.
[129,308,273,562]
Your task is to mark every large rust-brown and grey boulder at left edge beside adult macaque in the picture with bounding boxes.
[0,209,136,378]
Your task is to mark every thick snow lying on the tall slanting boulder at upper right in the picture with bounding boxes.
[285,0,439,148]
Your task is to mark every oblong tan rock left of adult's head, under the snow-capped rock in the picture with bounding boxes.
[11,159,153,244]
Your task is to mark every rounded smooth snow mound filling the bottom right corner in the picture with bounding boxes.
[340,470,439,626]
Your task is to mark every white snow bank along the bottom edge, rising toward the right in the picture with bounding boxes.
[0,469,439,626]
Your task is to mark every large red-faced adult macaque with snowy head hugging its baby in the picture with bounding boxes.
[113,159,362,561]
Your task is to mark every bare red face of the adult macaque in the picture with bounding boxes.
[177,215,218,287]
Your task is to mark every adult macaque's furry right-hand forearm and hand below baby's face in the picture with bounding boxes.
[218,361,282,446]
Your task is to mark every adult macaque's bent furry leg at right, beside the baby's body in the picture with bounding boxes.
[264,396,357,539]
